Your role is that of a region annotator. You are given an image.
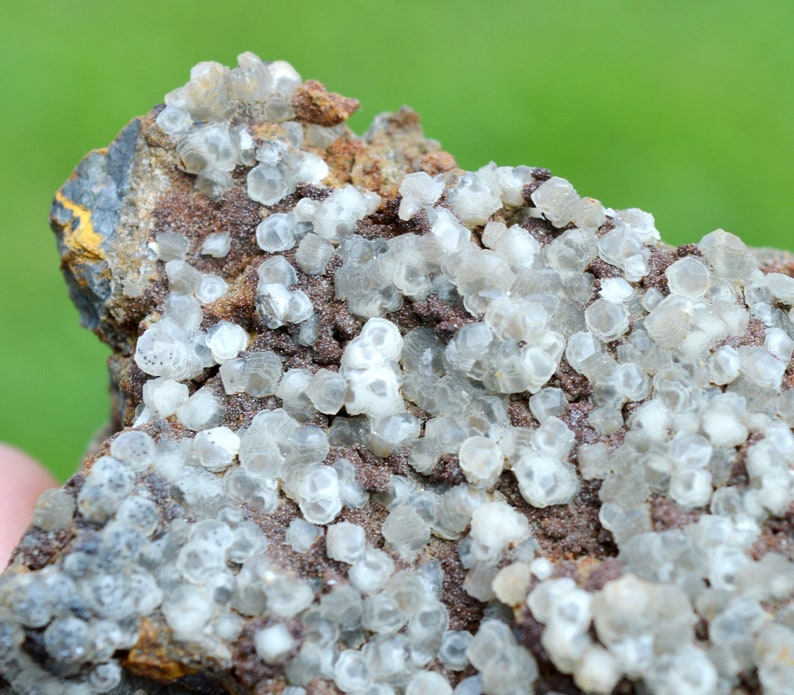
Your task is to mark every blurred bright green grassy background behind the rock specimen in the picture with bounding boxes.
[0,0,794,484]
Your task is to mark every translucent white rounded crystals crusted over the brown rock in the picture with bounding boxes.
[0,54,794,695]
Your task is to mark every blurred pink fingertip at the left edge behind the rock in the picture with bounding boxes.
[0,444,57,569]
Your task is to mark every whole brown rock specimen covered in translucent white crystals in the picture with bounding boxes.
[0,54,794,695]
